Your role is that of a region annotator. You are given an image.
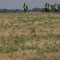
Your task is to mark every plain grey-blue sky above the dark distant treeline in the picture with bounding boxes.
[0,0,60,9]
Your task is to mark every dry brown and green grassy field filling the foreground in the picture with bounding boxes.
[0,12,60,60]
